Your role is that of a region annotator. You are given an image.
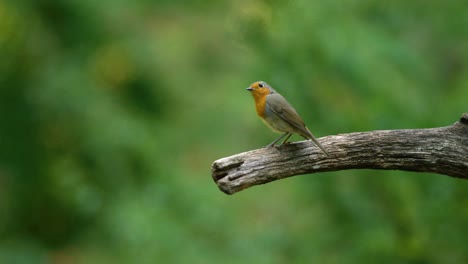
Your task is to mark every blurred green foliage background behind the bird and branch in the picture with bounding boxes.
[0,0,468,263]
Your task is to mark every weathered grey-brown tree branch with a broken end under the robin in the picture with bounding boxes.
[212,113,468,194]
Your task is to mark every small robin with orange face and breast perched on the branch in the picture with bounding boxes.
[247,81,330,156]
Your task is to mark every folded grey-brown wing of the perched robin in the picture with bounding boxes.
[266,93,310,138]
